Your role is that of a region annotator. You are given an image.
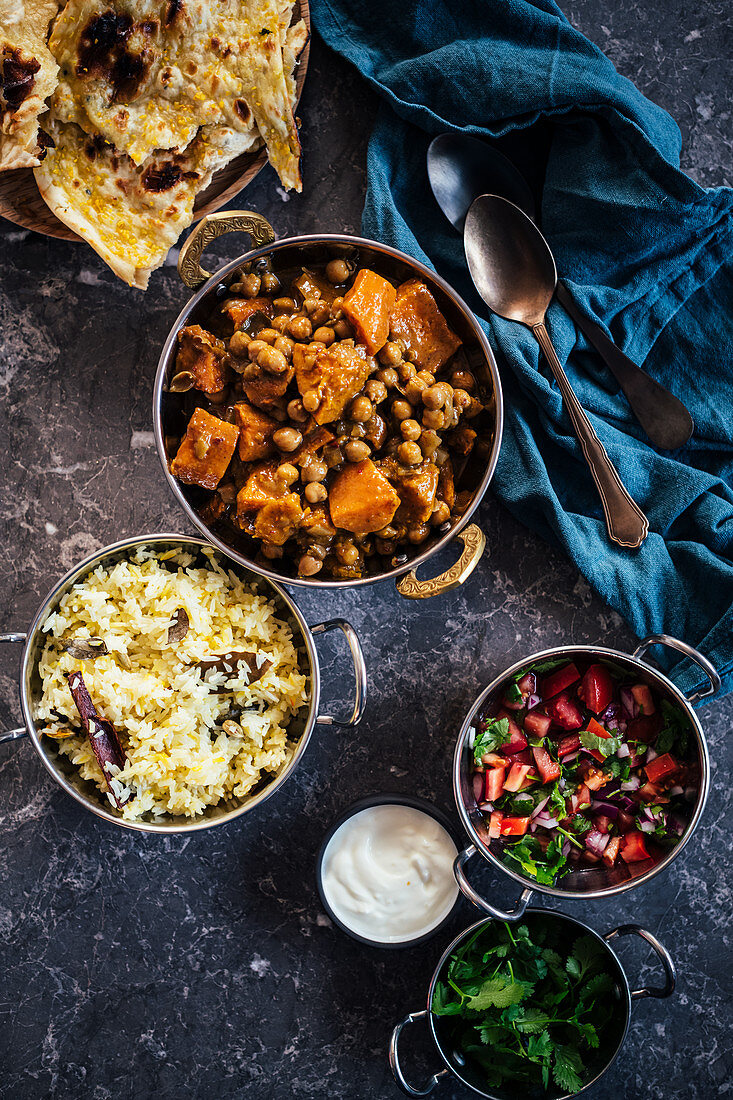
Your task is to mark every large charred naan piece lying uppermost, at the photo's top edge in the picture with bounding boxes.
[50,0,305,190]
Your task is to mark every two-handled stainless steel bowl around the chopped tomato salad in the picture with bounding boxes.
[453,635,720,921]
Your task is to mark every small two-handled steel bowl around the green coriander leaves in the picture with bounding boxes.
[390,909,676,1100]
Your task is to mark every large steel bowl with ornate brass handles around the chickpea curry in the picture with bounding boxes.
[153,211,503,600]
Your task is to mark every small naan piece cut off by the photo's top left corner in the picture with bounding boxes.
[0,0,58,172]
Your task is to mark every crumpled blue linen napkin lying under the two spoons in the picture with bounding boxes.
[311,0,733,692]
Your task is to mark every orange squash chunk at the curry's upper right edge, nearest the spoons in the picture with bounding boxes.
[390,278,462,374]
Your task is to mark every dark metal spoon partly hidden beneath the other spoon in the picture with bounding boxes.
[427,133,694,451]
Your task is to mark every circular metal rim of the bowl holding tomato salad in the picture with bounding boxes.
[453,645,710,900]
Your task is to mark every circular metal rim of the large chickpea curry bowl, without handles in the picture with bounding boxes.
[148,233,504,591]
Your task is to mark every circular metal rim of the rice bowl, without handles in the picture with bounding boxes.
[19,531,320,834]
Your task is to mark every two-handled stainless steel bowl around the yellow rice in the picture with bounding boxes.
[0,535,367,833]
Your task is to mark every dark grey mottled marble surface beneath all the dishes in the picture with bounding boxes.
[0,0,733,1100]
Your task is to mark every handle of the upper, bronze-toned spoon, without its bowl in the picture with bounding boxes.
[532,321,649,549]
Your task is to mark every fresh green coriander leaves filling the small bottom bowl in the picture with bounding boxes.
[431,916,624,1100]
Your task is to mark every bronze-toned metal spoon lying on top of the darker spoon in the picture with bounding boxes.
[463,195,649,549]
